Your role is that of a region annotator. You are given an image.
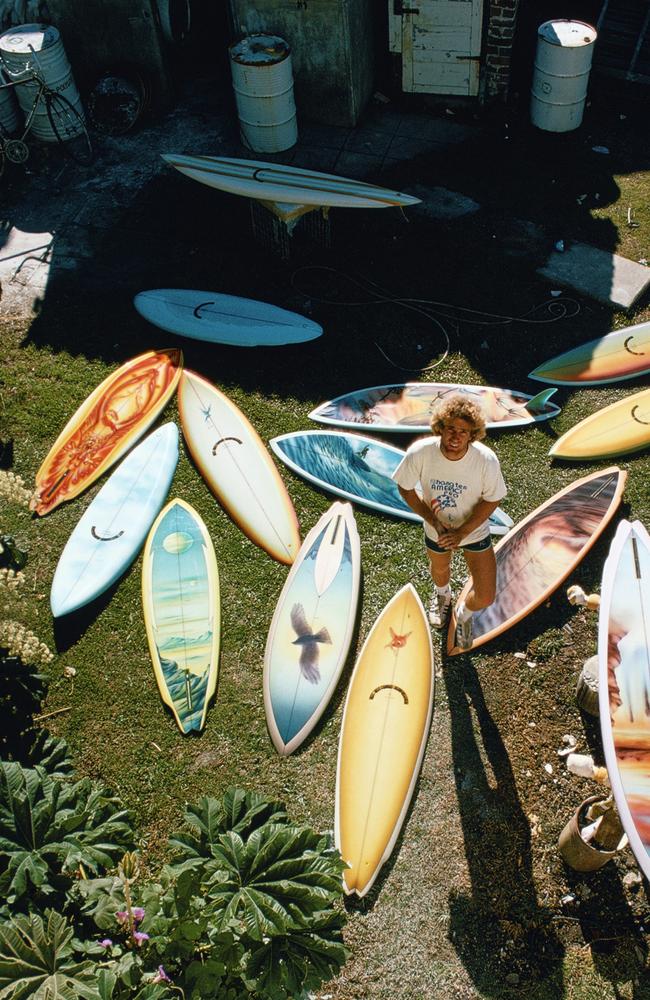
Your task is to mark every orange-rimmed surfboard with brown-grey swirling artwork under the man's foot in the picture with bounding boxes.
[447,466,627,656]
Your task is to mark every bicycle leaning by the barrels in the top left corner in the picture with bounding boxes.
[0,46,94,175]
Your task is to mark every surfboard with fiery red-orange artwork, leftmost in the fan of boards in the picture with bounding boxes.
[30,348,183,515]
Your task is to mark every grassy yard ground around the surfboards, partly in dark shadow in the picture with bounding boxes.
[0,74,650,1000]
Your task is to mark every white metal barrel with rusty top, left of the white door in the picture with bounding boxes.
[229,35,298,153]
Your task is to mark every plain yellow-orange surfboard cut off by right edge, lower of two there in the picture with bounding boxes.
[549,389,650,459]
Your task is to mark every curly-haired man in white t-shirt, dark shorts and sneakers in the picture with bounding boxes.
[393,395,506,649]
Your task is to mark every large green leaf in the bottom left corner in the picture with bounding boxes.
[0,910,98,1000]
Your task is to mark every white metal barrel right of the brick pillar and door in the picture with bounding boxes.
[530,20,598,132]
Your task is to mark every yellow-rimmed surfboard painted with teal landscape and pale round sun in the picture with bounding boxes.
[142,499,221,734]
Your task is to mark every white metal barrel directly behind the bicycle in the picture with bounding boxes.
[0,24,83,142]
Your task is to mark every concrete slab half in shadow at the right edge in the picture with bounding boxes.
[537,243,650,309]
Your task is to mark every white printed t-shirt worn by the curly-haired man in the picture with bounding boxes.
[392,437,507,545]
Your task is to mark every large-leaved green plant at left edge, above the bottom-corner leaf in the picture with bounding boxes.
[0,761,132,915]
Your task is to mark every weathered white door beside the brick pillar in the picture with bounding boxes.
[389,0,483,97]
